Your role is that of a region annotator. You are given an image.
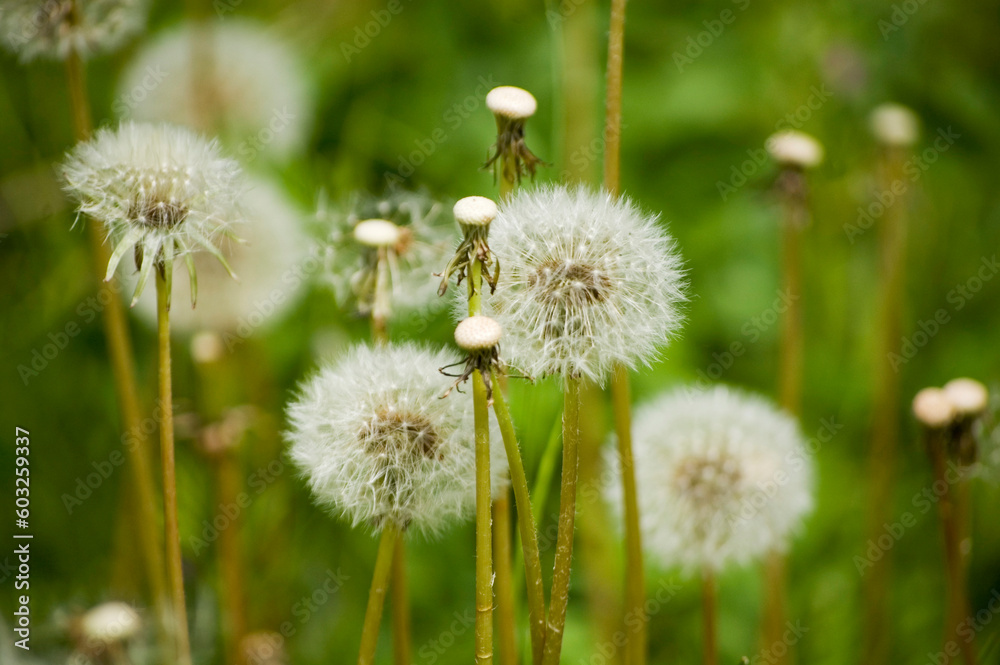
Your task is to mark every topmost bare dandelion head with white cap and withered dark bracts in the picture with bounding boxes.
[486,85,543,182]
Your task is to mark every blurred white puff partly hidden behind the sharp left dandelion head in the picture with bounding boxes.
[126,178,312,332]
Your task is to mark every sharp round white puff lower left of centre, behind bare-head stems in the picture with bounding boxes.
[286,345,507,533]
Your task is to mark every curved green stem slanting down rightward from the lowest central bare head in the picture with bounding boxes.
[493,370,545,663]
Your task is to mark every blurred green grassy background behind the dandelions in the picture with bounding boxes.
[0,0,1000,665]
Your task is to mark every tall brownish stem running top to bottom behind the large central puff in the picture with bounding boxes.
[604,0,647,665]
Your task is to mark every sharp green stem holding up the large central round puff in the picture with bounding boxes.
[542,376,580,665]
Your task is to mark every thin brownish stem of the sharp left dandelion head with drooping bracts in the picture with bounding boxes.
[156,264,191,665]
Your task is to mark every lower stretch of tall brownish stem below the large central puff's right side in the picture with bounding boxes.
[611,365,648,665]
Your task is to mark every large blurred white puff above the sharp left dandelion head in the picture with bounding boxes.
[115,20,312,161]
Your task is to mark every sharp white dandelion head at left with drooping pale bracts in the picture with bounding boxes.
[63,122,243,304]
